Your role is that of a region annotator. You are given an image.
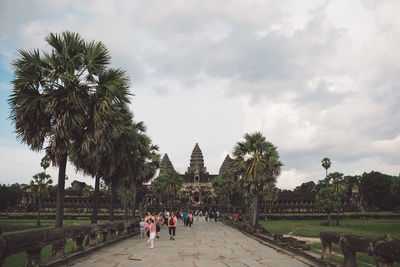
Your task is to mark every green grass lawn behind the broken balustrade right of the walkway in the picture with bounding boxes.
[260,219,400,267]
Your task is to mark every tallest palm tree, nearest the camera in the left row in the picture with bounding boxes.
[9,32,128,227]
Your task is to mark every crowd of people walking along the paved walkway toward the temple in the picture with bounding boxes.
[139,209,220,248]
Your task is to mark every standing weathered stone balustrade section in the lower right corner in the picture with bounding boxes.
[320,232,400,267]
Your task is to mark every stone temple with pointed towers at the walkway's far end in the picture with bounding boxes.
[160,143,229,206]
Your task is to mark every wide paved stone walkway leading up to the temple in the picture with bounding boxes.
[68,218,308,267]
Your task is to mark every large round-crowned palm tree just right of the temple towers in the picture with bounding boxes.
[232,132,283,228]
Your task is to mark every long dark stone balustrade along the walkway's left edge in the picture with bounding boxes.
[0,219,139,266]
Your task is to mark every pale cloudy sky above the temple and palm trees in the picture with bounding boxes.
[0,0,400,189]
